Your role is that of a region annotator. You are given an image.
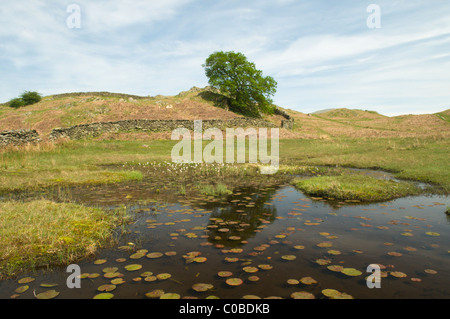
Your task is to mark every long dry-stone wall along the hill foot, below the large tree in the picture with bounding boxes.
[49,117,282,140]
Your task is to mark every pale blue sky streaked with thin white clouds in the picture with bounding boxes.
[0,0,450,116]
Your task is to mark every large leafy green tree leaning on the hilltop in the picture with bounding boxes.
[202,51,277,116]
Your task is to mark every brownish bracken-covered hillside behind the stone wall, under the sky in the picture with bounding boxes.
[0,87,450,139]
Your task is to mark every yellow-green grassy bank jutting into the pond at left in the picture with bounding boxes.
[0,200,127,279]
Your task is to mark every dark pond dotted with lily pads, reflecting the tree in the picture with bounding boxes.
[0,178,450,299]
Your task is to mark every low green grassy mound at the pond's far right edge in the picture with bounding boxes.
[293,175,421,202]
